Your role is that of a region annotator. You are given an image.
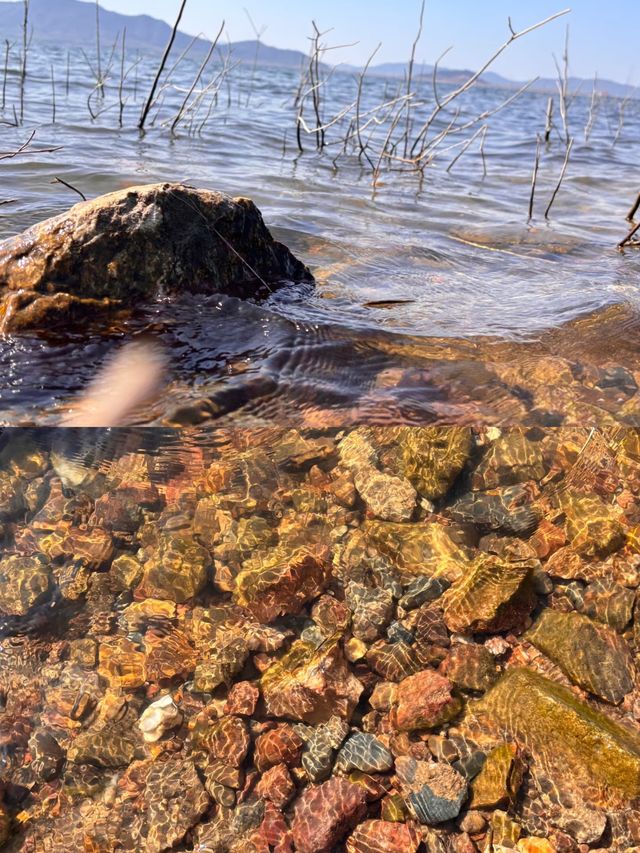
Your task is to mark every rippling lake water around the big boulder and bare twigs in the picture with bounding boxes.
[0,43,640,424]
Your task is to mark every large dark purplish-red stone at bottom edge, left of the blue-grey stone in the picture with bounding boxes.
[291,776,367,853]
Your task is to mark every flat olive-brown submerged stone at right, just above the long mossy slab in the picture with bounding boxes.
[526,610,633,704]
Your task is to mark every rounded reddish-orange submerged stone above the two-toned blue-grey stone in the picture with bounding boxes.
[392,669,460,731]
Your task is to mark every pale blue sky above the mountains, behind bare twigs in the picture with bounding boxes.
[95,0,640,83]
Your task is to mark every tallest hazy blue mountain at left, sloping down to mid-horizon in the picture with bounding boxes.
[0,0,306,69]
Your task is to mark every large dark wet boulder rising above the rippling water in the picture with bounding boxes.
[0,184,312,332]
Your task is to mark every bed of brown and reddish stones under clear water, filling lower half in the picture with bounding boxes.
[0,427,640,853]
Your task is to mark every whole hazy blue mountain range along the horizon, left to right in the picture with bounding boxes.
[0,0,640,97]
